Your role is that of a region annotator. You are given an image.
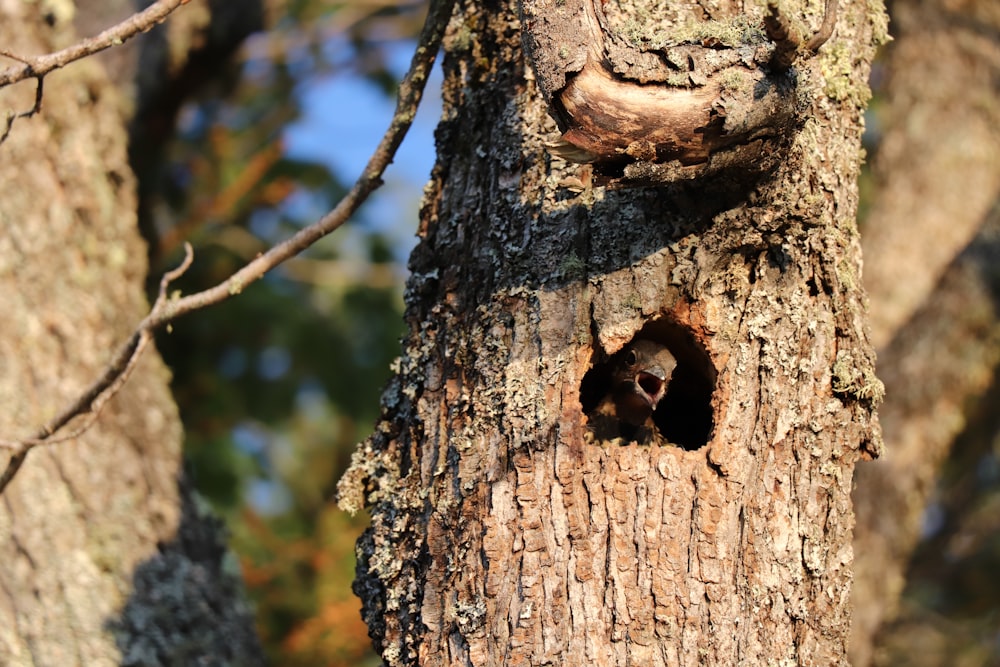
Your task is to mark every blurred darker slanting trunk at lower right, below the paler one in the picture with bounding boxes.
[851,206,1000,667]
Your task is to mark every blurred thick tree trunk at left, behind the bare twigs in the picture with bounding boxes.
[0,6,260,667]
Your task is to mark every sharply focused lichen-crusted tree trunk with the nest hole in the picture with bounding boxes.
[341,1,886,665]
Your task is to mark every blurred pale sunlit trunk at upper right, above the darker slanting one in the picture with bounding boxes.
[863,0,1000,350]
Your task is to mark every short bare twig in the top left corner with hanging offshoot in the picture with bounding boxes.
[0,0,190,144]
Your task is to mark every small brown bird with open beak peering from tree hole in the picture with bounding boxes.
[589,340,677,444]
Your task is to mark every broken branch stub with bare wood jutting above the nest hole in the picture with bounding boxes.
[521,0,824,186]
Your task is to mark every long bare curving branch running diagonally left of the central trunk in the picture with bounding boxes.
[0,0,455,494]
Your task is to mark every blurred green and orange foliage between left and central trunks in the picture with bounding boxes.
[136,0,424,666]
